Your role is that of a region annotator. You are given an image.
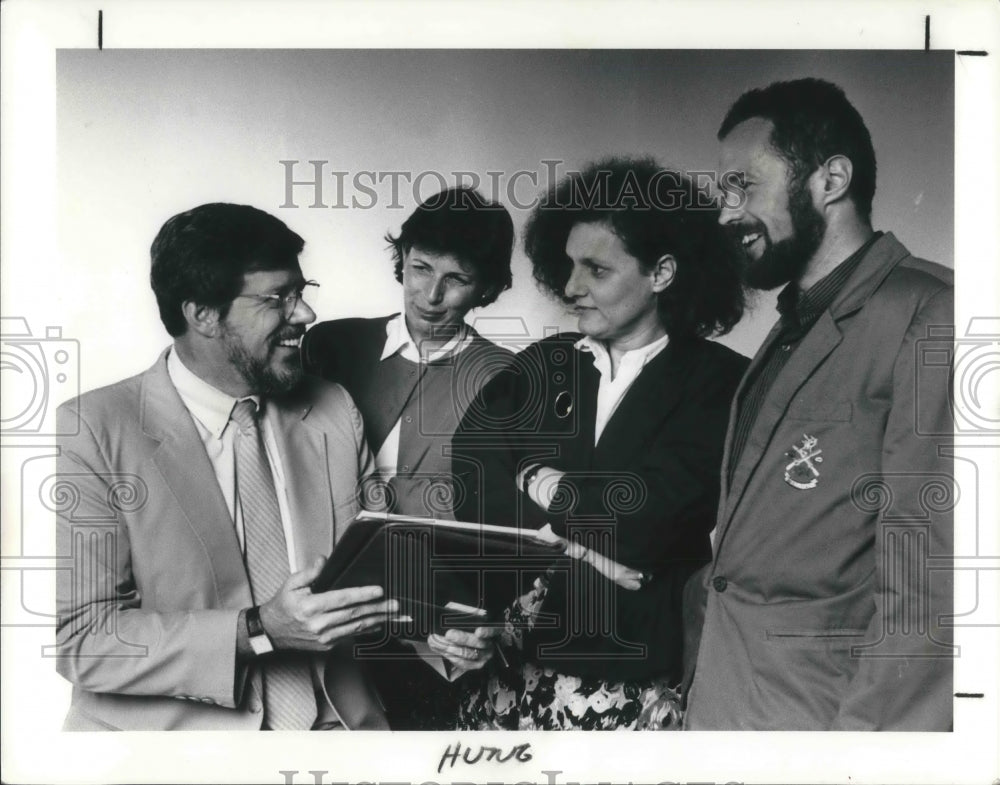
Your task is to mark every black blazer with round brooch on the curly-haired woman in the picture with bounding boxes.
[453,334,747,679]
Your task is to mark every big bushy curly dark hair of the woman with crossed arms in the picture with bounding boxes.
[524,157,744,337]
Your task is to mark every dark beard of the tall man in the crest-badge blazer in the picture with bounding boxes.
[739,177,826,290]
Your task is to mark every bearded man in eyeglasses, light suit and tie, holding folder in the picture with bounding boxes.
[56,204,396,730]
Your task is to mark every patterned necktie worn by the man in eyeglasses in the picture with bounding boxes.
[230,399,316,730]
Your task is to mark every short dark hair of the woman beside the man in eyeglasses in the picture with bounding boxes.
[385,185,514,305]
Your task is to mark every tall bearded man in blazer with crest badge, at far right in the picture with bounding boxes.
[686,79,955,731]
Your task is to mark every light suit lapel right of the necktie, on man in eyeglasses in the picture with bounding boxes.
[271,401,338,569]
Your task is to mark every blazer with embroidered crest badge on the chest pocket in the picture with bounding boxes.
[686,234,955,730]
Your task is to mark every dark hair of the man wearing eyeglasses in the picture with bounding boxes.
[149,202,305,338]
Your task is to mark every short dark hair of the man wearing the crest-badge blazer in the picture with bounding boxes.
[718,78,877,220]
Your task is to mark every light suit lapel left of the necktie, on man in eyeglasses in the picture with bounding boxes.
[139,352,250,606]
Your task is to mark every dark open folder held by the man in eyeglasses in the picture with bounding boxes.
[311,511,568,639]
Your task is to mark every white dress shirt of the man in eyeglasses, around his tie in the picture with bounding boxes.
[167,349,296,573]
